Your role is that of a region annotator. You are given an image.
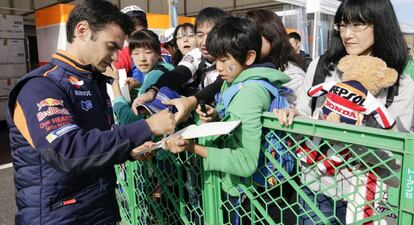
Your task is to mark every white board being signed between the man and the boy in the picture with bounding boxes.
[136,120,241,154]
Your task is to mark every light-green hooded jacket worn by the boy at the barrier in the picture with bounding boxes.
[201,67,290,196]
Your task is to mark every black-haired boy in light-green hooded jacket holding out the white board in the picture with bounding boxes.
[164,17,290,224]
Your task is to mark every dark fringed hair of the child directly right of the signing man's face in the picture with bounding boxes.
[128,30,161,55]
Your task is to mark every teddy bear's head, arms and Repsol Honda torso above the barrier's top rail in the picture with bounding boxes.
[308,55,398,129]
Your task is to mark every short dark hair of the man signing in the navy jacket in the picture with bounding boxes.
[66,0,133,43]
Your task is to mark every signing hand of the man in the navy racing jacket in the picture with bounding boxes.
[146,110,175,136]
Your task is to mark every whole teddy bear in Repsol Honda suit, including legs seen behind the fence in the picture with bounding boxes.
[297,55,398,175]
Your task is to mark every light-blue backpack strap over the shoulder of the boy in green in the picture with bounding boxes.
[221,80,279,110]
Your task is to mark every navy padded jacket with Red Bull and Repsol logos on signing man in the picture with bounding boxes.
[7,51,151,225]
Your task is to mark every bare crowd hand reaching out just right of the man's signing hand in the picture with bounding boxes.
[162,96,197,124]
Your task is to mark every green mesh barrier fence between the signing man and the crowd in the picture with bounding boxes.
[117,113,414,225]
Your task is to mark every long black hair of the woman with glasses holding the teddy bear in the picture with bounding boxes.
[320,0,408,76]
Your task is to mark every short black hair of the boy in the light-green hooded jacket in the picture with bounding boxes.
[206,16,262,65]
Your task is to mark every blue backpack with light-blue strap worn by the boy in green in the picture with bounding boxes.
[221,80,296,187]
